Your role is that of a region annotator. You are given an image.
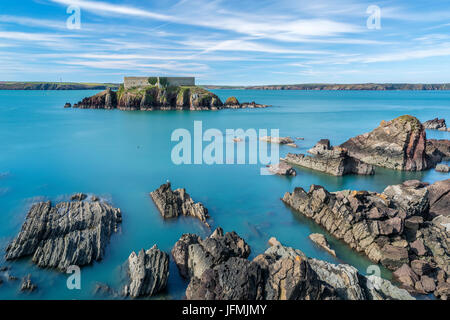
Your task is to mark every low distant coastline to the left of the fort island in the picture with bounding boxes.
[0,81,119,90]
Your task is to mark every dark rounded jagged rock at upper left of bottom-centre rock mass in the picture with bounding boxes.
[172,228,250,278]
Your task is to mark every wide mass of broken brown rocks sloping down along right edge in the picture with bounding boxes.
[283,180,450,299]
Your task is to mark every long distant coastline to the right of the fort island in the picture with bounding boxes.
[202,83,450,91]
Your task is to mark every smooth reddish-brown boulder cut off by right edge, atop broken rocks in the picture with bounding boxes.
[427,179,450,217]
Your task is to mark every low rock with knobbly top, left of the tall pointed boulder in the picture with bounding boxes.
[283,139,374,176]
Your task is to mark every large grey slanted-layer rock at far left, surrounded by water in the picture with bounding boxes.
[6,195,122,271]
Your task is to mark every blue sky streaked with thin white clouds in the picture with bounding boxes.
[0,0,450,85]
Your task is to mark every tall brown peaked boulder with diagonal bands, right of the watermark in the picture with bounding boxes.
[341,115,432,171]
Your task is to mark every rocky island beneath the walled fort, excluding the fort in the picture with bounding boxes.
[73,86,267,111]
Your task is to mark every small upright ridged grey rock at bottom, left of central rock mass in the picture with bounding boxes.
[122,245,169,298]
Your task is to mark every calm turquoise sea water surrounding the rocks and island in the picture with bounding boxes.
[0,90,450,299]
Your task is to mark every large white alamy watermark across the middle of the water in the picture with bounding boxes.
[171,121,280,175]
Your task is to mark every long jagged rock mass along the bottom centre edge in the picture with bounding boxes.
[172,228,413,300]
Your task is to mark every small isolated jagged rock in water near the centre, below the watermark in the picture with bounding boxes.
[150,182,209,227]
